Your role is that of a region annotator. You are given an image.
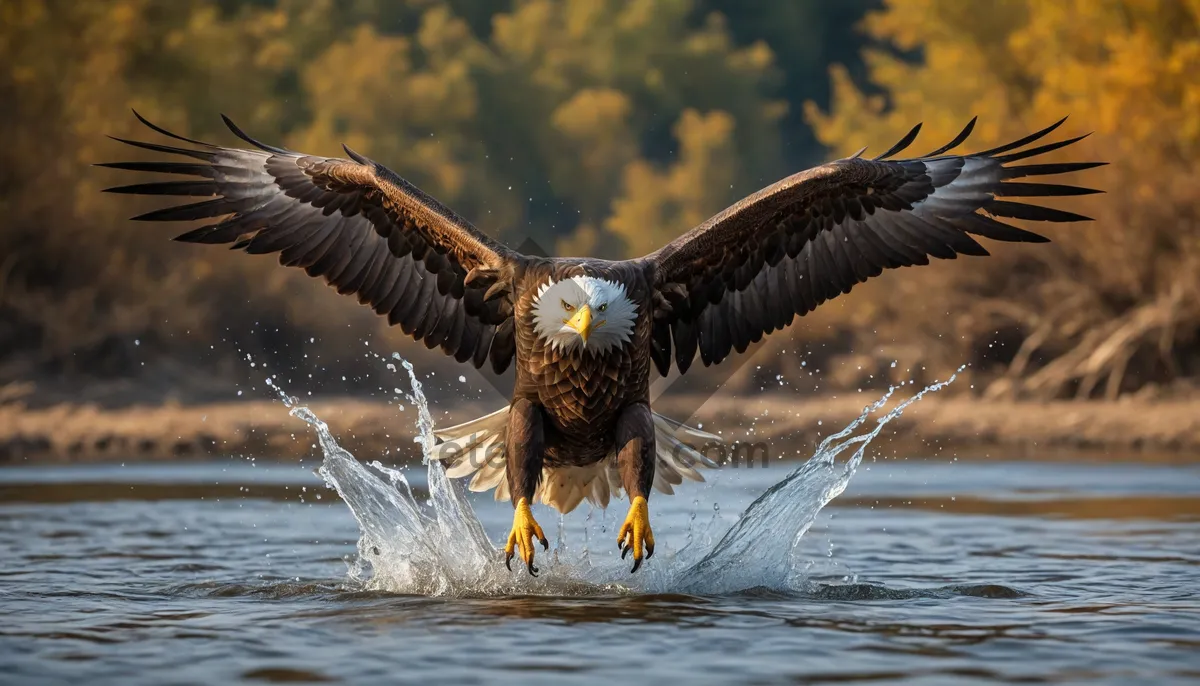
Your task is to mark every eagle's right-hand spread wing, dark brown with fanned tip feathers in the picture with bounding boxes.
[644,119,1104,374]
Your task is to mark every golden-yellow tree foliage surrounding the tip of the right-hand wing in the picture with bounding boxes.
[805,0,1200,378]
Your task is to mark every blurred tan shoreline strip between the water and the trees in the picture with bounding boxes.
[0,393,1200,467]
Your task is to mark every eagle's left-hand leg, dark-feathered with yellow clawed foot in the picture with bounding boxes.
[504,398,550,577]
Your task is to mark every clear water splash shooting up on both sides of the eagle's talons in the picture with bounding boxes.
[271,354,955,596]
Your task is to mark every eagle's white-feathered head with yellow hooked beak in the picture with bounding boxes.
[533,276,637,354]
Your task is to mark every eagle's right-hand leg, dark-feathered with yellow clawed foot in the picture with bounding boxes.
[617,403,655,573]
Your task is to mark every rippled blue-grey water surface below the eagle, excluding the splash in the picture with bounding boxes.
[0,450,1200,684]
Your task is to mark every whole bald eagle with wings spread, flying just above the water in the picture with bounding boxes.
[104,113,1102,574]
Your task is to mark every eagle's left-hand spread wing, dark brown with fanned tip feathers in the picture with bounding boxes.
[101,113,521,373]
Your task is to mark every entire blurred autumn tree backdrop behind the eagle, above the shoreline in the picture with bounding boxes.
[0,0,1200,405]
